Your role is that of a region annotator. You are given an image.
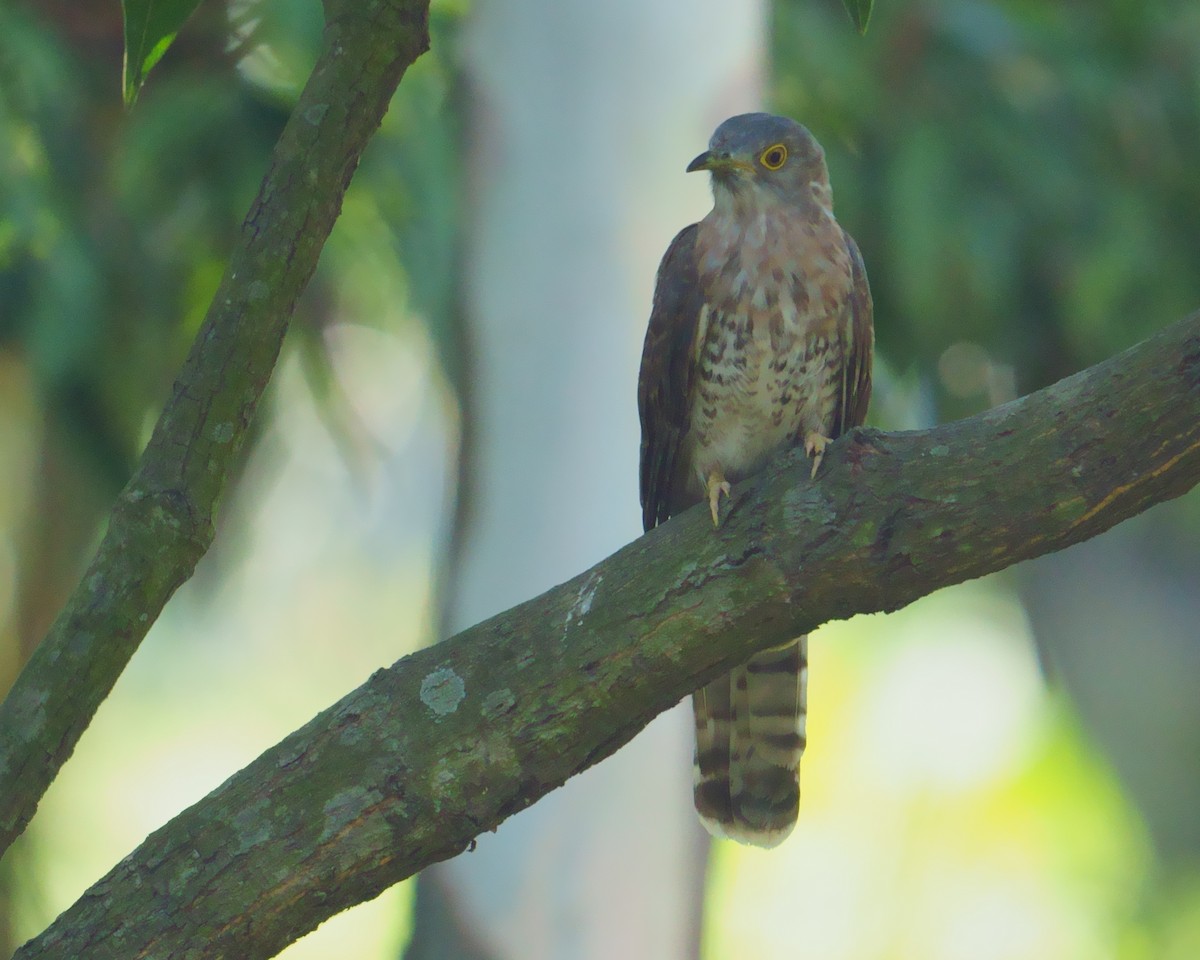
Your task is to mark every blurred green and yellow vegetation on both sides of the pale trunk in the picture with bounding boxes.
[0,0,1200,958]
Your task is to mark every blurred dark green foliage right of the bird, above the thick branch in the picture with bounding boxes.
[772,0,1200,419]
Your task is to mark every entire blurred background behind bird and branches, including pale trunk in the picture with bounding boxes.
[0,0,1200,960]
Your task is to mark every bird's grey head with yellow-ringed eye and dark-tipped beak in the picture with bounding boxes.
[688,113,829,205]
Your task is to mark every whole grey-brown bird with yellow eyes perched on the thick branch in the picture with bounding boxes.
[637,113,875,847]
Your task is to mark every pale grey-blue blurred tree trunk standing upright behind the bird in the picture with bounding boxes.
[407,0,764,960]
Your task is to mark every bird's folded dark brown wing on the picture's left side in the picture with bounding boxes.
[637,223,703,530]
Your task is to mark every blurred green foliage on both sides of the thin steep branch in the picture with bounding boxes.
[0,0,461,585]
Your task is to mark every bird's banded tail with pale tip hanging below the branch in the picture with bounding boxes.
[692,637,809,847]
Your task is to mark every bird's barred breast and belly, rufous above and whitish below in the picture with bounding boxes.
[684,211,853,498]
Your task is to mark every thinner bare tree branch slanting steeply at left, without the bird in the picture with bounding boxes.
[0,0,428,853]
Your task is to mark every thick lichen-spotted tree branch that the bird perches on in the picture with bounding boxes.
[17,314,1200,960]
